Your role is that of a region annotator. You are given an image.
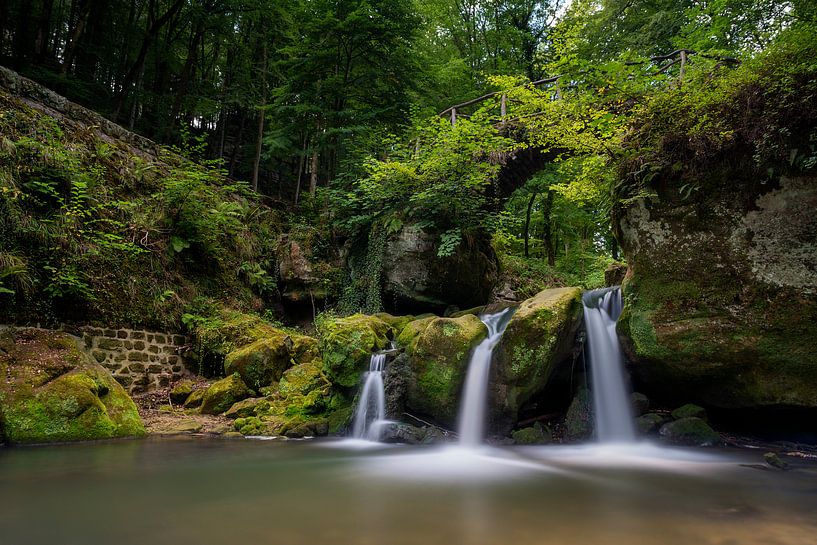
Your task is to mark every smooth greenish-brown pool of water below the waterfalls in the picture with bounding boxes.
[0,438,817,545]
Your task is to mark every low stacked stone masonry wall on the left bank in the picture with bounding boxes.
[81,327,187,394]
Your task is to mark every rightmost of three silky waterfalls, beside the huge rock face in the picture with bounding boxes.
[582,287,636,443]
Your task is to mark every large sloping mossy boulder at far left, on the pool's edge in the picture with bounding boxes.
[0,329,145,443]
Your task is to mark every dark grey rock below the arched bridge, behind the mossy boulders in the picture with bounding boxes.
[383,226,499,313]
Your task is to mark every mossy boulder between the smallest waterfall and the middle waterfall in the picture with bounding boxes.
[397,314,488,428]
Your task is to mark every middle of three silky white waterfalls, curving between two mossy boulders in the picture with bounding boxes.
[458,308,515,447]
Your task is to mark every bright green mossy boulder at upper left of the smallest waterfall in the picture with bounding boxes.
[318,314,393,388]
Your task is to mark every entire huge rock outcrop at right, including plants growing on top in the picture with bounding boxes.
[614,41,817,409]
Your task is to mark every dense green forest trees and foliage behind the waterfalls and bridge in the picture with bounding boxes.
[0,0,817,323]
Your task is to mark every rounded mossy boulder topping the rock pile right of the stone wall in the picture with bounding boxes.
[224,329,293,390]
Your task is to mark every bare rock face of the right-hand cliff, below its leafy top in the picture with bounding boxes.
[617,176,817,408]
